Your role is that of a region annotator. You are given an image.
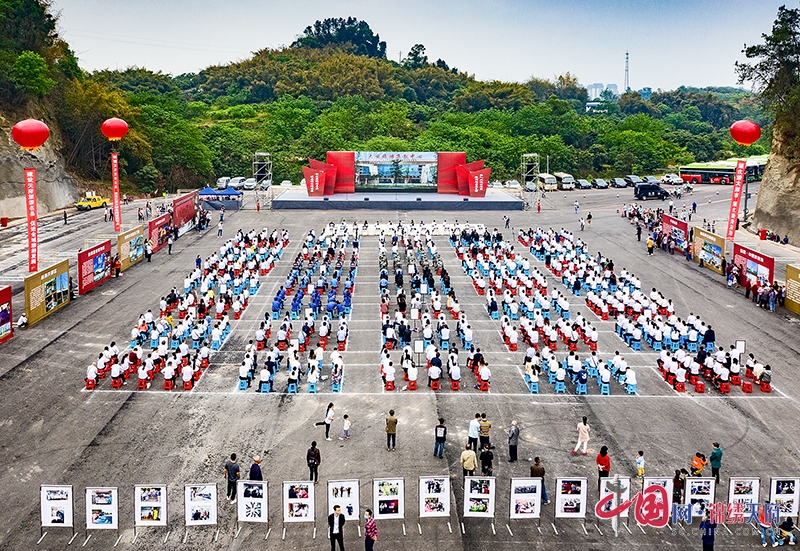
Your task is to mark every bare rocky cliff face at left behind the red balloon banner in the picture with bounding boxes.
[0,114,79,218]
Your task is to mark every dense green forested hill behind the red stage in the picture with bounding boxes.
[0,4,770,190]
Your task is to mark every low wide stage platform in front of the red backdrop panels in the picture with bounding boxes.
[272,187,524,212]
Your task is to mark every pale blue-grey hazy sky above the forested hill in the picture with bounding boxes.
[53,0,784,90]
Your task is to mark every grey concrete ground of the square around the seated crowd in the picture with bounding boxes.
[0,186,800,551]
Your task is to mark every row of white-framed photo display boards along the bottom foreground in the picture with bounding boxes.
[41,476,800,530]
